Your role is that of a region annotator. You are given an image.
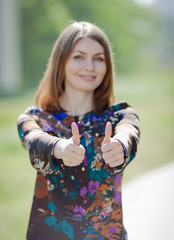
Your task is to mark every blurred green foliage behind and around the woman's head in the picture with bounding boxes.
[21,0,156,88]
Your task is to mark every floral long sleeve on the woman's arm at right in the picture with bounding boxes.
[114,106,140,172]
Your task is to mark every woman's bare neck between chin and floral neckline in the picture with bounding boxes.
[61,88,93,116]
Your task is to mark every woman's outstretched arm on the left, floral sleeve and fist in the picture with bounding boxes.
[18,108,85,174]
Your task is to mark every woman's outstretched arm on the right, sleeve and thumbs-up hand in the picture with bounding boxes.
[102,104,140,172]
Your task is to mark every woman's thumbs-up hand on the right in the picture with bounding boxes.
[101,122,124,167]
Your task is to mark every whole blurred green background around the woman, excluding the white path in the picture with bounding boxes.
[0,0,174,240]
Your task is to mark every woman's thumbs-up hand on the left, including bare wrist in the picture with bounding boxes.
[54,122,85,167]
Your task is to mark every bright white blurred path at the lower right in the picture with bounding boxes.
[122,162,174,240]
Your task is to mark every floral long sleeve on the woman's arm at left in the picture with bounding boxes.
[17,108,64,174]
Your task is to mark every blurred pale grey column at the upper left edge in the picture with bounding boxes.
[0,0,22,97]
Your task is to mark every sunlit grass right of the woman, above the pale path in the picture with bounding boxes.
[115,74,174,183]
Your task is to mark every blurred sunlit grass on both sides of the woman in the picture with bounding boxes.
[0,74,174,240]
